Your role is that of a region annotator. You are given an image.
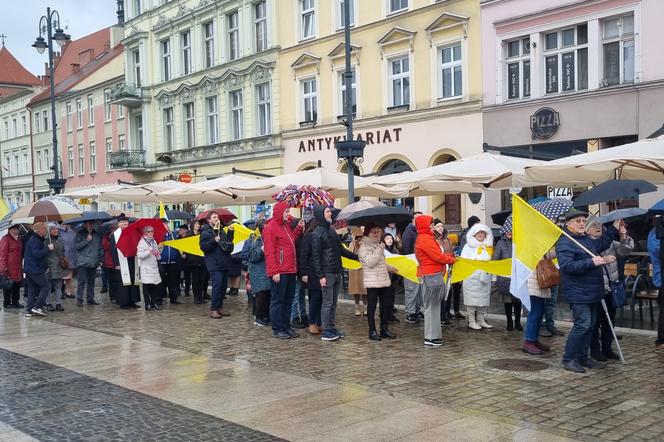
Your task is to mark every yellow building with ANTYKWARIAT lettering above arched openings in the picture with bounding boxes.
[278,0,483,225]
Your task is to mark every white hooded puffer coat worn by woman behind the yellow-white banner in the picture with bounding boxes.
[461,223,493,307]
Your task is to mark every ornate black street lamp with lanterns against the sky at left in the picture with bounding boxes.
[32,8,71,194]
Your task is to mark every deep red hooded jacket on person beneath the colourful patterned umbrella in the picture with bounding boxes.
[263,202,302,277]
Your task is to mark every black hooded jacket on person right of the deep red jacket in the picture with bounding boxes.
[311,206,358,279]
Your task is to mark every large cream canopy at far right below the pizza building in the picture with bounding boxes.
[517,136,664,186]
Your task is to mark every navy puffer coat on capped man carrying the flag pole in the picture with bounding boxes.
[556,226,618,304]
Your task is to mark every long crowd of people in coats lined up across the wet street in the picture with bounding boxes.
[0,202,664,373]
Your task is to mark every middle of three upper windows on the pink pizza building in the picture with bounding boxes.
[544,24,588,94]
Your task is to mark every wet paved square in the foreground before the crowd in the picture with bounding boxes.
[0,296,664,440]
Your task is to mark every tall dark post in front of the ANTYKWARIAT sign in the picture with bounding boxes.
[334,0,366,204]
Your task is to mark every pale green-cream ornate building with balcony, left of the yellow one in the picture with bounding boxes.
[116,0,283,197]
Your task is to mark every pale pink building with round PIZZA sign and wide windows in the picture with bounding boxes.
[481,0,664,215]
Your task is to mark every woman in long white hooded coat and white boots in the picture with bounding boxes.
[461,223,493,330]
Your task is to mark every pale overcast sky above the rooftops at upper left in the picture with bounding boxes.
[0,0,117,75]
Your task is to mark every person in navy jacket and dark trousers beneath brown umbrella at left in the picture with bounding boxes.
[23,222,55,317]
